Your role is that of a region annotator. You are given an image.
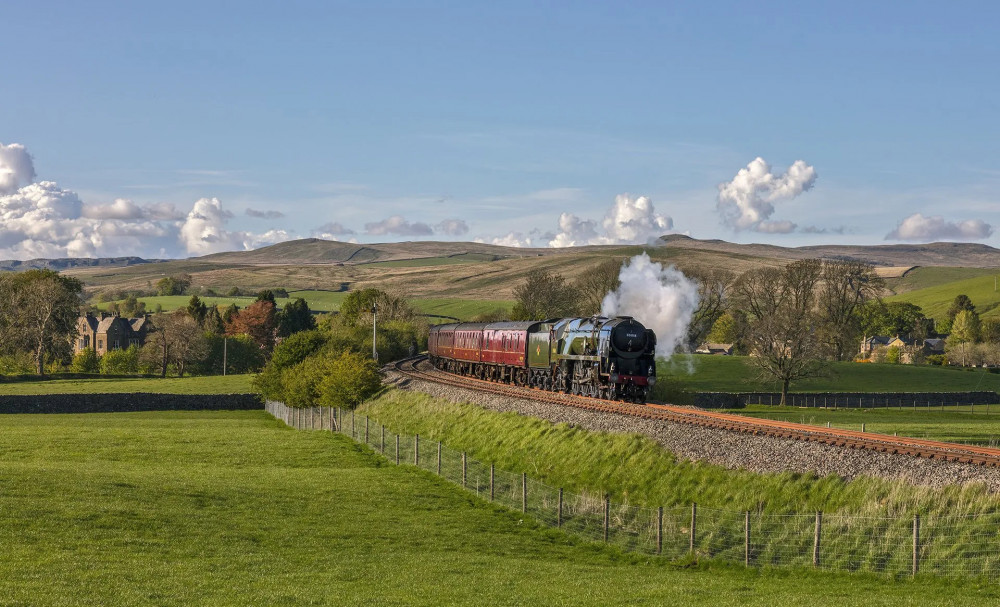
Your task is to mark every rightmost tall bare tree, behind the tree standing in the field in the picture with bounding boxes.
[819,261,885,360]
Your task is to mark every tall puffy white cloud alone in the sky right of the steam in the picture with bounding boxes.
[716,157,816,234]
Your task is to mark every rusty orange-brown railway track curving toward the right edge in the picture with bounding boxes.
[393,356,1000,468]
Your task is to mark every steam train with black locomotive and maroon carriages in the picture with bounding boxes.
[427,316,656,403]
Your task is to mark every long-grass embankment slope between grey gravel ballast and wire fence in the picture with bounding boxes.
[358,390,1000,516]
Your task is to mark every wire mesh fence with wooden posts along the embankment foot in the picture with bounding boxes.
[266,401,1000,580]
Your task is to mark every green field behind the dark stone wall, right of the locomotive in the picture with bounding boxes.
[654,354,1000,398]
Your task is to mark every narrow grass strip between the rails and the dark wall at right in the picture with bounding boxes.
[729,405,1000,446]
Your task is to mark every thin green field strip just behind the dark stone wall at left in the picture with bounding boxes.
[0,374,253,395]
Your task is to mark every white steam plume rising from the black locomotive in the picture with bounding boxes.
[601,253,698,358]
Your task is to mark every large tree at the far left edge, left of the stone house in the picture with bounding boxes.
[0,270,83,375]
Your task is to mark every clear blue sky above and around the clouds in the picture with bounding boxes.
[0,2,1000,256]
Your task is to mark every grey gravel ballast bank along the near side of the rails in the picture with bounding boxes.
[386,363,1000,492]
